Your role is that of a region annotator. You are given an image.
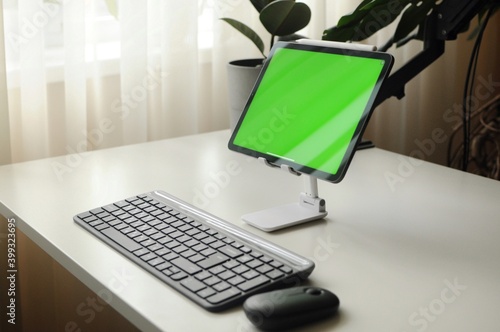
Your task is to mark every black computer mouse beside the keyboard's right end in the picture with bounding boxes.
[243,286,340,330]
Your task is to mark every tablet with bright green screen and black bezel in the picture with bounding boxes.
[228,42,393,183]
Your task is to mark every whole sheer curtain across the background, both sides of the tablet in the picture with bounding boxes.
[0,0,500,163]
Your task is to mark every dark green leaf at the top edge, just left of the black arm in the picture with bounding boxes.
[394,0,436,42]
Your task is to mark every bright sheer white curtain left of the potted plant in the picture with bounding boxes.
[0,0,258,164]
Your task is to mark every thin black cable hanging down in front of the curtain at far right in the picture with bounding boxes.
[462,8,494,171]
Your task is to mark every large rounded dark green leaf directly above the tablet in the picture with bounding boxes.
[259,0,311,36]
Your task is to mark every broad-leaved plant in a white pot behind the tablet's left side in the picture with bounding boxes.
[221,0,311,129]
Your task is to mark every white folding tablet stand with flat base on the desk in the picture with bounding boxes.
[242,158,328,232]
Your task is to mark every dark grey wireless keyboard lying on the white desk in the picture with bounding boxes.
[74,191,314,312]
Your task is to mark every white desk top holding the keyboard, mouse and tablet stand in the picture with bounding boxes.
[0,131,500,332]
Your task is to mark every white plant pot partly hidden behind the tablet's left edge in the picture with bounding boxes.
[227,59,264,130]
